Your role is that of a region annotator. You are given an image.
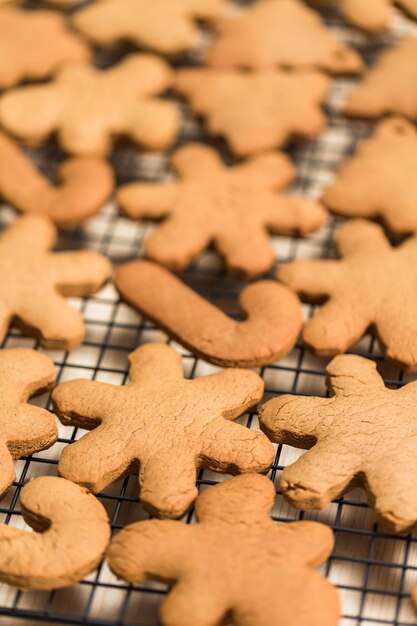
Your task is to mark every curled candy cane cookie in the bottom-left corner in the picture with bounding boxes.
[0,476,110,589]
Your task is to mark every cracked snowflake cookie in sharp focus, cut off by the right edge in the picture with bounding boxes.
[260,354,417,532]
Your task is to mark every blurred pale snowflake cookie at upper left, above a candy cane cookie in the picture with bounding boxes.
[0,54,179,155]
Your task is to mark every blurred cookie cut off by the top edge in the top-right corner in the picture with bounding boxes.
[310,0,417,33]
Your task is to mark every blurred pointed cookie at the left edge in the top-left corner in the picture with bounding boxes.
[0,7,90,89]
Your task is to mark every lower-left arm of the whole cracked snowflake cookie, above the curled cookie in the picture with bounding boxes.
[58,426,132,493]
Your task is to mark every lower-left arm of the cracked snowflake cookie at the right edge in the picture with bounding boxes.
[281,441,361,510]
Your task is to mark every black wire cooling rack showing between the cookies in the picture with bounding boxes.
[0,0,417,626]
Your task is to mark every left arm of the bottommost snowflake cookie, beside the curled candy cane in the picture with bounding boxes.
[107,520,191,583]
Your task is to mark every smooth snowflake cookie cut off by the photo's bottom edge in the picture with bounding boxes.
[107,474,340,626]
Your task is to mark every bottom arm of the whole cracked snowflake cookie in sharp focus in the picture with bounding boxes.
[139,446,198,519]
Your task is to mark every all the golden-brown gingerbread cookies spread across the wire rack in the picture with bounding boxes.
[0,0,417,626]
